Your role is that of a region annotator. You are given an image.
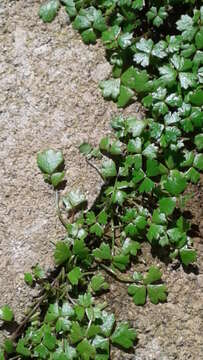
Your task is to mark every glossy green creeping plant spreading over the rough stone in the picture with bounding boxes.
[0,0,203,360]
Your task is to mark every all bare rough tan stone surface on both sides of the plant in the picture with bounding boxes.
[0,0,203,360]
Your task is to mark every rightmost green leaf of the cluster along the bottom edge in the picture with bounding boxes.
[111,323,137,349]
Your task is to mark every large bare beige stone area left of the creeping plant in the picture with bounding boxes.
[0,0,117,326]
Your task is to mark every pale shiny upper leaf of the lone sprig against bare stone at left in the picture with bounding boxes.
[37,149,64,175]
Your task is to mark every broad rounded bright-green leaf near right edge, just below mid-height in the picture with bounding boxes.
[164,170,187,196]
